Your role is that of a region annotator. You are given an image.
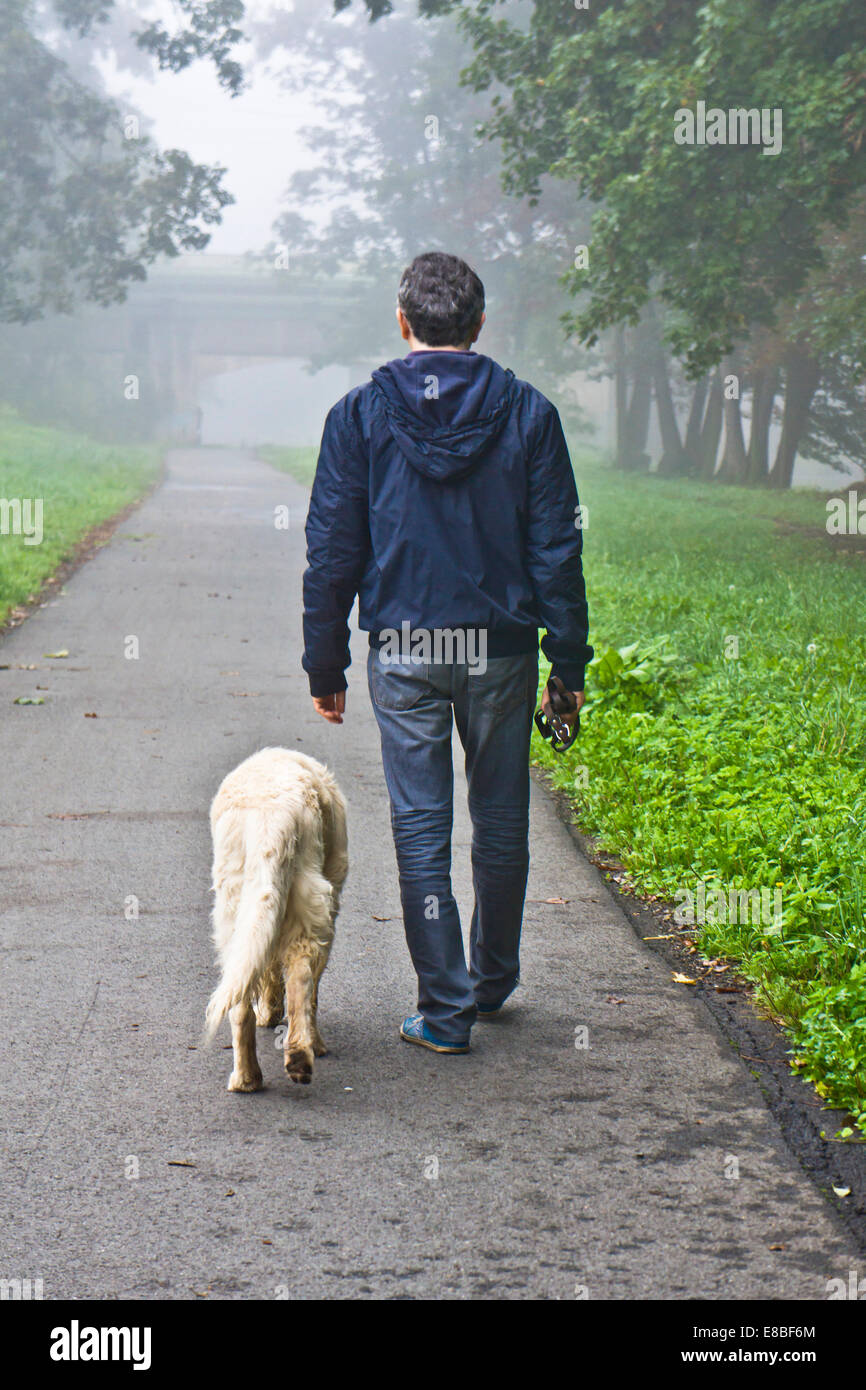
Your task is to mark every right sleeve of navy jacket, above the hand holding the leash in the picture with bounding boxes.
[527,400,594,691]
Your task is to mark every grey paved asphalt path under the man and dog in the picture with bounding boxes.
[0,449,856,1300]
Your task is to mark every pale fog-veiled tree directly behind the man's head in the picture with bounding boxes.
[252,3,600,407]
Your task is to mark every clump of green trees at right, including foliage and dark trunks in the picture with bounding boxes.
[353,0,866,487]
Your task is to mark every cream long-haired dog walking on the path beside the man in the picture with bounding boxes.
[206,748,349,1091]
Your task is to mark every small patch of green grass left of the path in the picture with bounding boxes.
[0,407,160,623]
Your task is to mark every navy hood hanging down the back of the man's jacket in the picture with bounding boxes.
[373,352,514,482]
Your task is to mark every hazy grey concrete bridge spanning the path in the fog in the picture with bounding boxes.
[0,253,366,443]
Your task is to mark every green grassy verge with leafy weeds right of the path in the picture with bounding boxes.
[535,459,866,1133]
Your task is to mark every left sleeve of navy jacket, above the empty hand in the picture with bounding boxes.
[302,398,370,695]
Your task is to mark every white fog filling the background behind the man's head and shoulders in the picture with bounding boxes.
[0,0,866,488]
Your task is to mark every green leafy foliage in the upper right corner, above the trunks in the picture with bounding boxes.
[400,0,866,375]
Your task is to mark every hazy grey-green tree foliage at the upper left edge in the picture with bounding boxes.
[0,0,243,322]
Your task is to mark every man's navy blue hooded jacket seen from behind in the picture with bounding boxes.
[303,352,592,695]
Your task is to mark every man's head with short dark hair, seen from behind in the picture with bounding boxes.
[398,252,484,348]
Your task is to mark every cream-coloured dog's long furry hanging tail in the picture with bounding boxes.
[204,809,296,1038]
